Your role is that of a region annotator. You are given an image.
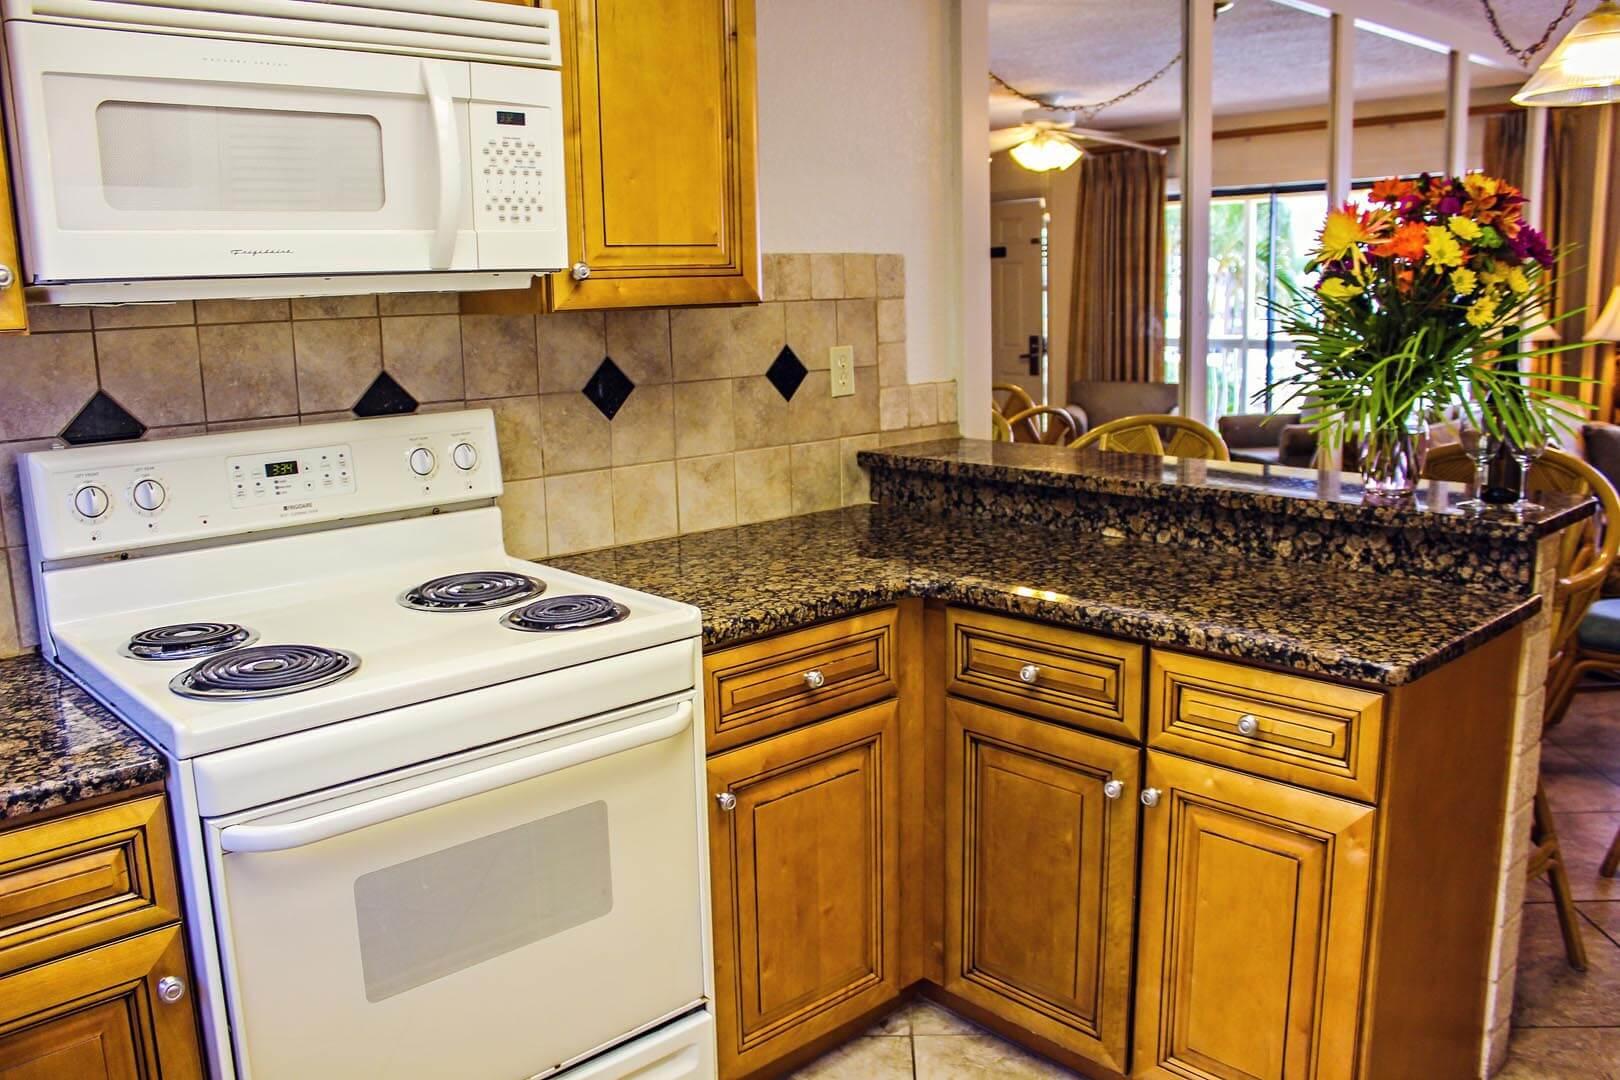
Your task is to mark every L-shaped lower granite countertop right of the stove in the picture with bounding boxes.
[552,507,1541,685]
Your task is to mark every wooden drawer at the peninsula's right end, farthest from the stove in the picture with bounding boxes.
[1147,651,1383,803]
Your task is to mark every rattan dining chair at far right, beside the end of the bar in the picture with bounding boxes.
[1424,444,1620,972]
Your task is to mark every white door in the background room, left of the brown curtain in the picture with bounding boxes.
[990,199,1047,405]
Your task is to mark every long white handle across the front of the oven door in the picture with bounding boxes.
[219,701,692,855]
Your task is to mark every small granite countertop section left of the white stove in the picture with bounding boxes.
[0,654,164,819]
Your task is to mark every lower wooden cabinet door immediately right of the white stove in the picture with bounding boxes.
[708,701,901,1077]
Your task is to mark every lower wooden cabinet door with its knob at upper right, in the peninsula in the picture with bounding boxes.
[946,698,1140,1070]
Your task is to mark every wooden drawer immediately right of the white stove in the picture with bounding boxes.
[703,607,896,753]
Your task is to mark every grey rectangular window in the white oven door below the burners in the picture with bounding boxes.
[355,801,612,1002]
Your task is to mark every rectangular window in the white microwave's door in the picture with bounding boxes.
[96,100,384,210]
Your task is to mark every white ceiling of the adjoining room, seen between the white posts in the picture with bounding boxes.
[990,0,1568,130]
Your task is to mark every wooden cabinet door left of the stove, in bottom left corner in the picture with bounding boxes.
[0,926,203,1080]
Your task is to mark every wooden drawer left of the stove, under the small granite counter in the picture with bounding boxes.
[0,795,180,972]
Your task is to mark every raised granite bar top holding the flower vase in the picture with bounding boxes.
[860,439,1596,542]
